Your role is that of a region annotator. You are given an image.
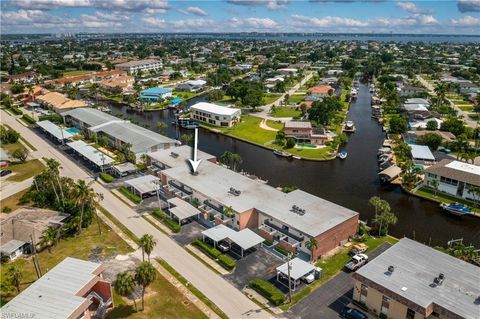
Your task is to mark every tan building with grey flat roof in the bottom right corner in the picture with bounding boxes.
[352,238,480,319]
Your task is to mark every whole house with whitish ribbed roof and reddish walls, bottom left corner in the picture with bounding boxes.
[0,257,113,319]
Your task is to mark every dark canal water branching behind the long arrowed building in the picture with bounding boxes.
[99,84,480,246]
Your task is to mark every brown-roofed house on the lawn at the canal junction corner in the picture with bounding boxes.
[283,121,329,145]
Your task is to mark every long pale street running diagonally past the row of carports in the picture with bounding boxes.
[0,110,271,318]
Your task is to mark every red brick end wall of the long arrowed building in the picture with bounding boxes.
[313,215,358,259]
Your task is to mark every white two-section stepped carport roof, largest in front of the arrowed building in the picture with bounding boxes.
[202,224,265,258]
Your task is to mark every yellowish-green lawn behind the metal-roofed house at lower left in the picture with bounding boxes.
[1,220,132,303]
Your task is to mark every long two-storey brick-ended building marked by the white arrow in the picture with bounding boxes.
[151,148,358,259]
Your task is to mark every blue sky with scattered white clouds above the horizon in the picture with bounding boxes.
[0,0,480,34]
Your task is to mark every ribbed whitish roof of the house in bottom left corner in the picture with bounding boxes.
[0,257,102,319]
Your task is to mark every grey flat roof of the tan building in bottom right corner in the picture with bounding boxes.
[354,238,480,318]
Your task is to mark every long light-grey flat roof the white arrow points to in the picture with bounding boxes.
[162,161,358,237]
